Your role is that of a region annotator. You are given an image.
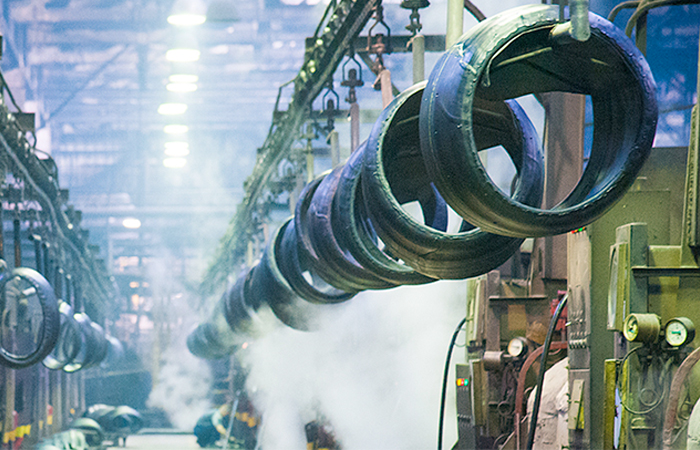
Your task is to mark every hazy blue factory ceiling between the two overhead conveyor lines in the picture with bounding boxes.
[0,0,325,278]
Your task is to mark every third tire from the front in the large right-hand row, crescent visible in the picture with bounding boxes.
[333,142,437,285]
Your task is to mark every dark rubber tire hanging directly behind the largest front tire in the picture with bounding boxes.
[362,83,544,279]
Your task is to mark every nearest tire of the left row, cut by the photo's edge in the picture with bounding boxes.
[0,267,61,369]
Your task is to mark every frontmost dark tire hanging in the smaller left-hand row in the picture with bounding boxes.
[0,267,61,369]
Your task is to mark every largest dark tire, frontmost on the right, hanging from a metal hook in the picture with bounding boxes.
[421,5,658,237]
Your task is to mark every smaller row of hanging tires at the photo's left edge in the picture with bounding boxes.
[0,267,124,373]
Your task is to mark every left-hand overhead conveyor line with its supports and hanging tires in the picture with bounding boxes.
[0,42,134,448]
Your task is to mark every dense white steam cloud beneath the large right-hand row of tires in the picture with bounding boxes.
[241,281,466,450]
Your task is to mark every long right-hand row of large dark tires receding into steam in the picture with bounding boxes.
[188,5,658,358]
